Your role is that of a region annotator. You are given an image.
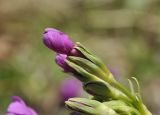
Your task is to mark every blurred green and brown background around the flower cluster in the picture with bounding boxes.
[0,0,160,115]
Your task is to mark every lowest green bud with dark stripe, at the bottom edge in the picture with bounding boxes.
[66,98,118,115]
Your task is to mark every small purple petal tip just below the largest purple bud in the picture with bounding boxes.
[55,54,73,72]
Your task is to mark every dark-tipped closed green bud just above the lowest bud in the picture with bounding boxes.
[83,81,131,103]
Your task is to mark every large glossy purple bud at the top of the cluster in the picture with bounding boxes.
[43,28,74,54]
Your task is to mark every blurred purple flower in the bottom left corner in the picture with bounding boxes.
[6,96,38,115]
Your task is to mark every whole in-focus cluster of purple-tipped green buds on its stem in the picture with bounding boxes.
[43,28,152,115]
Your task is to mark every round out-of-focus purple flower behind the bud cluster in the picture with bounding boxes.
[60,77,82,101]
